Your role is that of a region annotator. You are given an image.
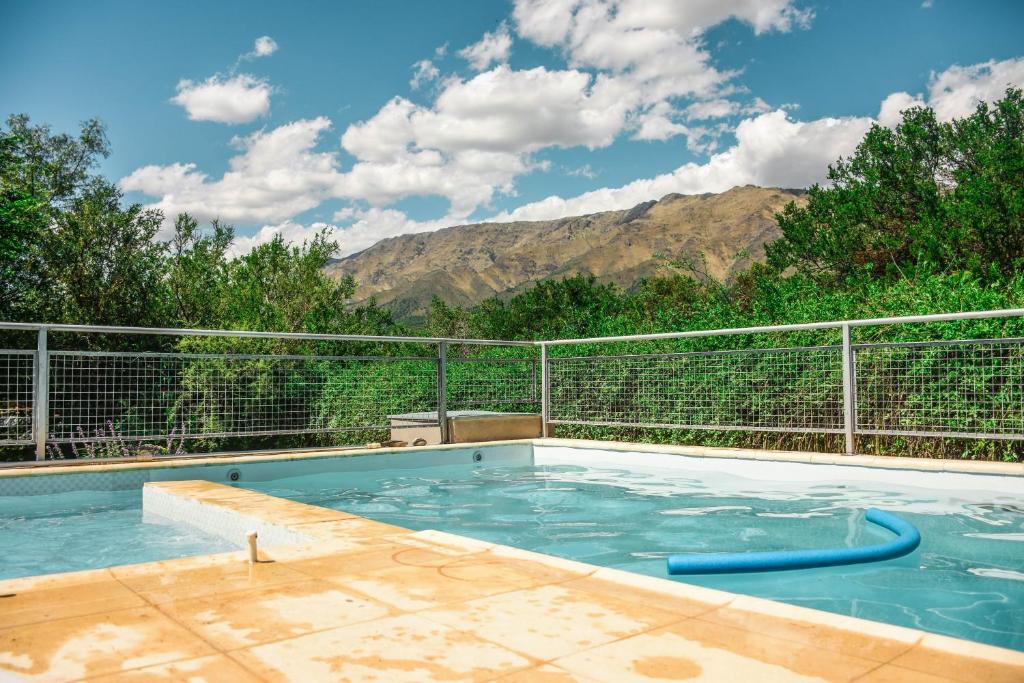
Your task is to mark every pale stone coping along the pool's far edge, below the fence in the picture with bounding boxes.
[0,438,1024,477]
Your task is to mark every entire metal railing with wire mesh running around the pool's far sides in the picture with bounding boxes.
[0,309,1024,459]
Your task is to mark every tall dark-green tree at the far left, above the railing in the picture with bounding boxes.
[0,115,164,325]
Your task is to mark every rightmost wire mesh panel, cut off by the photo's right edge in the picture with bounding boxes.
[853,339,1024,439]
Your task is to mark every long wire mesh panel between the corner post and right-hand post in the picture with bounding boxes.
[550,346,844,432]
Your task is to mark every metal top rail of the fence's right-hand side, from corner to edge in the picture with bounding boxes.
[536,308,1024,346]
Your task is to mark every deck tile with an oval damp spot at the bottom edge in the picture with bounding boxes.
[554,629,856,683]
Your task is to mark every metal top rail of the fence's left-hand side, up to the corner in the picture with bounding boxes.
[0,322,536,346]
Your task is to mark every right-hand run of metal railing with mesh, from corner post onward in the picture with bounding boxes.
[541,308,1024,454]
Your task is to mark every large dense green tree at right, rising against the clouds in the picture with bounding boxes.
[768,88,1024,282]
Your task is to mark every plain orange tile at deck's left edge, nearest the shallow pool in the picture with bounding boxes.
[0,569,145,629]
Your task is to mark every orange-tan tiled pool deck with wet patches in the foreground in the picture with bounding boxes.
[0,471,1024,683]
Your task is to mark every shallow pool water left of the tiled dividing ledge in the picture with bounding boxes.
[0,488,238,579]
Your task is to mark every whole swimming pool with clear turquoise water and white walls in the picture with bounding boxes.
[0,443,1024,650]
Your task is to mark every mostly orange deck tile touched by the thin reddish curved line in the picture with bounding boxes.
[339,553,578,611]
